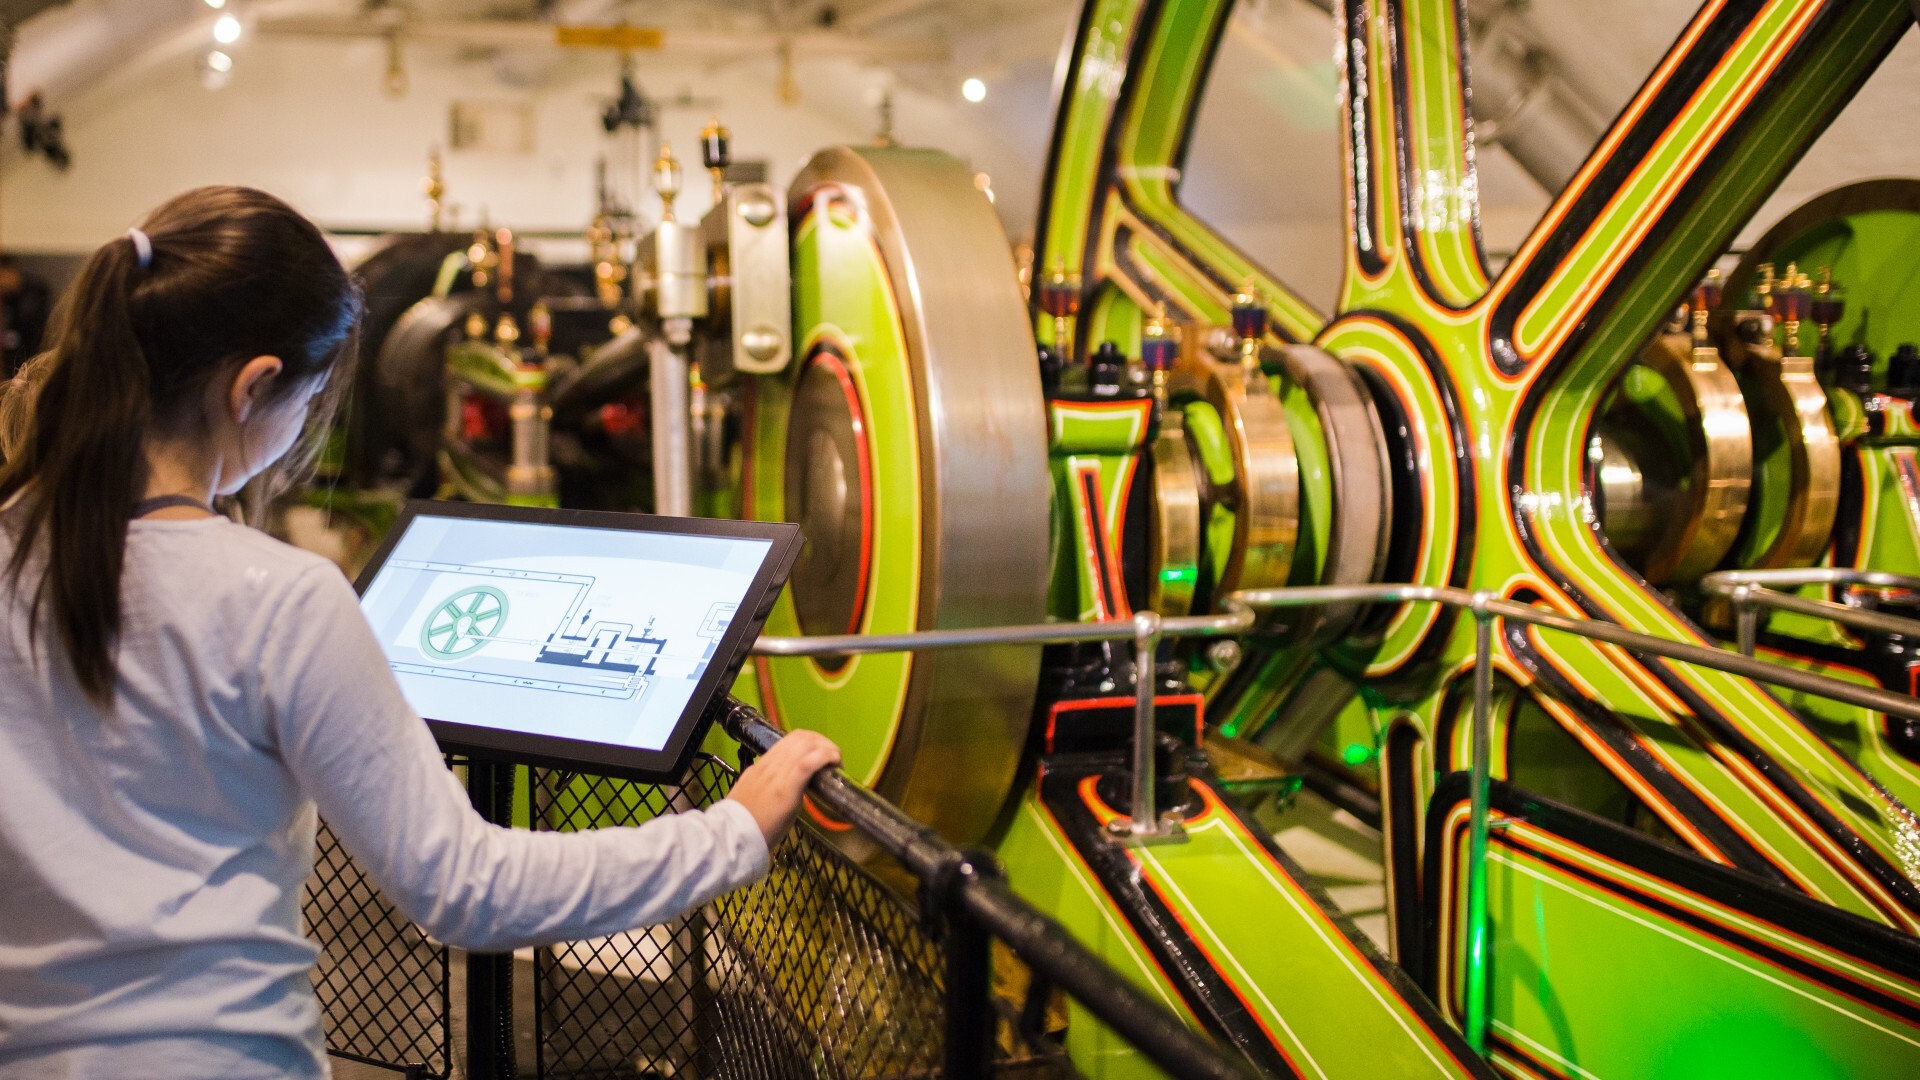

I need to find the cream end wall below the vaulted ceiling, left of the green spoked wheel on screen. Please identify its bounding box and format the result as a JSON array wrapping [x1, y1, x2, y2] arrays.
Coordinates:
[[0, 27, 1066, 252]]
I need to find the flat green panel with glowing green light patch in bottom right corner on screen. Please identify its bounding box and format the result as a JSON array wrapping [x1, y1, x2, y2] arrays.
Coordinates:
[[1448, 813, 1920, 1080]]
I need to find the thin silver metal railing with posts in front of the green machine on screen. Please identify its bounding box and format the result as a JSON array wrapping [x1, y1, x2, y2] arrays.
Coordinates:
[[753, 571, 1920, 1061]]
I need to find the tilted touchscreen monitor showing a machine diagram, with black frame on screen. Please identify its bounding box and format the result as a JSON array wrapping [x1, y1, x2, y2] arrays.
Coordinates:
[[357, 502, 799, 780]]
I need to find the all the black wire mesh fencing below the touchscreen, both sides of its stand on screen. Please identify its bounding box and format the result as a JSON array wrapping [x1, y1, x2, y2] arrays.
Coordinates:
[[303, 755, 1071, 1080]]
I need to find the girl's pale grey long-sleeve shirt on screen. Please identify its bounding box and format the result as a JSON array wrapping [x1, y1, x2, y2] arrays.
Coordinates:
[[0, 519, 766, 1080]]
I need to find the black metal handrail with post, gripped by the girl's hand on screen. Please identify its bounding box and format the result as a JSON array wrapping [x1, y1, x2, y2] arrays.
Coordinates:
[[716, 700, 1248, 1080]]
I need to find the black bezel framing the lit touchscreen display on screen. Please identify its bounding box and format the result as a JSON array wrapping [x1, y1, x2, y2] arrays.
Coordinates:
[[353, 500, 801, 784]]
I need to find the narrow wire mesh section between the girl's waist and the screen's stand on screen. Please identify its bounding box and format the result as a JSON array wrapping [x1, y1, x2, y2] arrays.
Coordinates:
[[301, 810, 453, 1076]]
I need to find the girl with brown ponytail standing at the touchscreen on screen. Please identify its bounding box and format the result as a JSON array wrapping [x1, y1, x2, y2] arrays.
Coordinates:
[[0, 188, 837, 1080]]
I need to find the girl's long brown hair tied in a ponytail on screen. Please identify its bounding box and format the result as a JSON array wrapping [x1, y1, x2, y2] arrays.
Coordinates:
[[0, 186, 361, 705]]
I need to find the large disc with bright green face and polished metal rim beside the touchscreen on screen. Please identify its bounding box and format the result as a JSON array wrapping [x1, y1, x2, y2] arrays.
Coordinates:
[[745, 148, 1050, 846]]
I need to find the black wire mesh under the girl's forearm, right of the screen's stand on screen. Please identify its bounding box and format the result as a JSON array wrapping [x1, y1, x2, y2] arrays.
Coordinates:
[[534, 757, 1058, 1080]]
